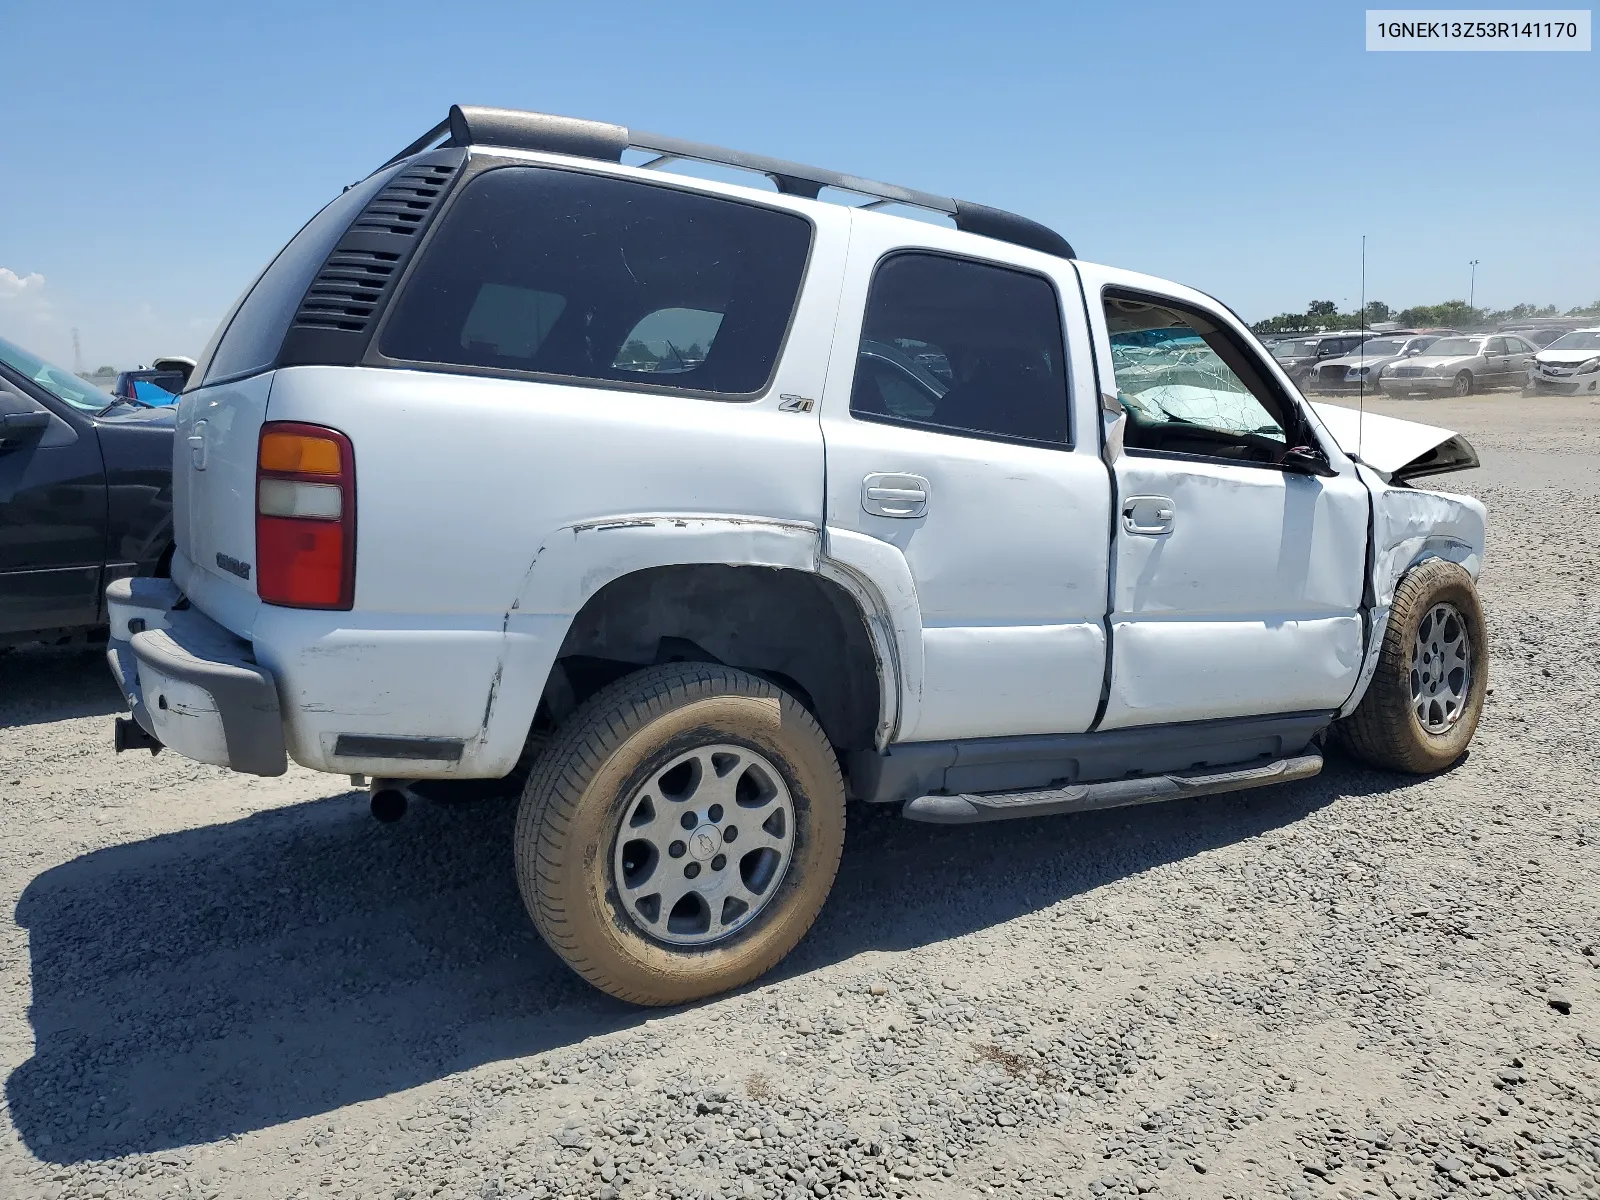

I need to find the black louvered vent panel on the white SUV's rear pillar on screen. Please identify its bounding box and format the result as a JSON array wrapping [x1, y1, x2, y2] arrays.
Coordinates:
[[280, 155, 459, 352]]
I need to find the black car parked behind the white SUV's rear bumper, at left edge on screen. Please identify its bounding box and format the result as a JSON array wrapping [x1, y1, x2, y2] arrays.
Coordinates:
[[0, 339, 174, 646]]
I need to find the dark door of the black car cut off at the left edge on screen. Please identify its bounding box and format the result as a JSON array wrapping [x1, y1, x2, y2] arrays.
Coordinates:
[[0, 376, 106, 638]]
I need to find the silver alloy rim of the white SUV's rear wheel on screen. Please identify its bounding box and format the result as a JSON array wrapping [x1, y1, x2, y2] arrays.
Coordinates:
[[611, 742, 795, 946]]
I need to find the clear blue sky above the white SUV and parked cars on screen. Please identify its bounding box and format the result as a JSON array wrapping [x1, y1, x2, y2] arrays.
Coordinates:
[[0, 0, 1600, 368]]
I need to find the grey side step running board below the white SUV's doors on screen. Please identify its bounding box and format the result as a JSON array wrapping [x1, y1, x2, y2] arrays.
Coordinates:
[[901, 754, 1322, 826]]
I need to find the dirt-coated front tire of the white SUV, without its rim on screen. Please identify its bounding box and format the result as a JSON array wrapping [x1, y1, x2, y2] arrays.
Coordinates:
[[1334, 558, 1490, 774]]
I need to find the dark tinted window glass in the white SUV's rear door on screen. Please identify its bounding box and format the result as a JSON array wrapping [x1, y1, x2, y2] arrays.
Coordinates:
[[850, 253, 1067, 443]]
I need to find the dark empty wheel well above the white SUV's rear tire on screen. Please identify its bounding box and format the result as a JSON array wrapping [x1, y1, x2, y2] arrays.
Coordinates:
[[539, 563, 882, 754]]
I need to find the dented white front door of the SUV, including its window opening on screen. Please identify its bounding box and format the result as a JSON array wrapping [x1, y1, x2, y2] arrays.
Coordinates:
[[1082, 267, 1370, 730]]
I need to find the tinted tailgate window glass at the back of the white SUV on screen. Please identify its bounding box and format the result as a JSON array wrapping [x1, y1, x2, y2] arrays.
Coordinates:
[[195, 165, 400, 384]]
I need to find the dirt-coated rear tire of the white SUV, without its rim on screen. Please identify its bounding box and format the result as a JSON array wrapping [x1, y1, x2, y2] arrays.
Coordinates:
[[515, 662, 845, 1005]]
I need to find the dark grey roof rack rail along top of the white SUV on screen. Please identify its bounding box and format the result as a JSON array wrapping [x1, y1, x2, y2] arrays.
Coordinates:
[[379, 104, 1077, 258]]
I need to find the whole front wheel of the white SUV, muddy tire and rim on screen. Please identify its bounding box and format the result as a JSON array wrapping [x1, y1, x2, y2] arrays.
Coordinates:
[[1334, 558, 1490, 774]]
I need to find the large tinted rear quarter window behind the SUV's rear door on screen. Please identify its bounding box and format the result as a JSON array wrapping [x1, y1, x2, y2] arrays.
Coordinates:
[[379, 166, 811, 395]]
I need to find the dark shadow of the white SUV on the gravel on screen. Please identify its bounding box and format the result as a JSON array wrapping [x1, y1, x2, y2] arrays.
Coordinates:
[[6, 761, 1394, 1163]]
